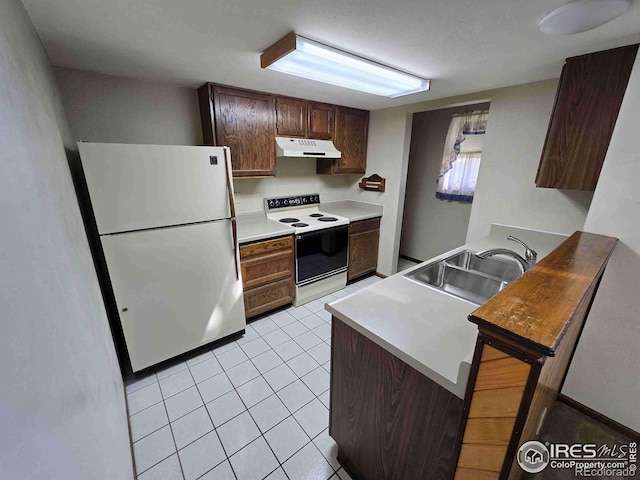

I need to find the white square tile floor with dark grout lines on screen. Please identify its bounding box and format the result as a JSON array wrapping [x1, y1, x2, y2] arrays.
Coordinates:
[[126, 277, 380, 480]]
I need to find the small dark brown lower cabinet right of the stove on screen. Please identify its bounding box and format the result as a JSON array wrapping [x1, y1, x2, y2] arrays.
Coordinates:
[[347, 218, 380, 280]]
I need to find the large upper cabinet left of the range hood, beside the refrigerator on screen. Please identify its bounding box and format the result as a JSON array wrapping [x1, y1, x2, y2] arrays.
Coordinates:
[[198, 84, 276, 177]]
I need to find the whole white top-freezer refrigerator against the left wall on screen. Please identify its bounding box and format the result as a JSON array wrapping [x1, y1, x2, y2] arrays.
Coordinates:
[[78, 142, 246, 372]]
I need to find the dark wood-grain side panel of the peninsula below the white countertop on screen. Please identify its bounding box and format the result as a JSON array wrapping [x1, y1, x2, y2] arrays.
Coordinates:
[[329, 317, 462, 480]]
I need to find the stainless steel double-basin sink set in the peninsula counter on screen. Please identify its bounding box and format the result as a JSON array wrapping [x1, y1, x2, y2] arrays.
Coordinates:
[[404, 250, 521, 305]]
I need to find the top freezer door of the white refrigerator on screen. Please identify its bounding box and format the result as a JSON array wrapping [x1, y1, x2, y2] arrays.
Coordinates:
[[78, 142, 233, 235]]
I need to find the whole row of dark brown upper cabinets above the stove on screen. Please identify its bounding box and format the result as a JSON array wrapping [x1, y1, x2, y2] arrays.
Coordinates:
[[198, 83, 369, 177]]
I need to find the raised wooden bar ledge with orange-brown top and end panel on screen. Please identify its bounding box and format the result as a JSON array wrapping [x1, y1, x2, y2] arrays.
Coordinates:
[[455, 232, 617, 480]]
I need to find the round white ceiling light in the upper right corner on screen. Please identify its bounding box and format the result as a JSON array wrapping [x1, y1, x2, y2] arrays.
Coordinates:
[[540, 0, 631, 35]]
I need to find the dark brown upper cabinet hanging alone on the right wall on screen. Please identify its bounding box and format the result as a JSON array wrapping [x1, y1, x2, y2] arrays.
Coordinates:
[[536, 45, 638, 190]]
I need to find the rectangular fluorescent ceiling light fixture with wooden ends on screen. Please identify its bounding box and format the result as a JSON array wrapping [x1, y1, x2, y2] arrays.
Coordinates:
[[260, 32, 431, 98]]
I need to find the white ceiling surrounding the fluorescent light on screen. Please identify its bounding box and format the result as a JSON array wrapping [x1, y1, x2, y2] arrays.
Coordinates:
[[23, 0, 640, 110]]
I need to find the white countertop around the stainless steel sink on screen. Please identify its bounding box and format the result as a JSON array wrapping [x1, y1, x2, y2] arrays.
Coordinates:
[[325, 225, 566, 398]]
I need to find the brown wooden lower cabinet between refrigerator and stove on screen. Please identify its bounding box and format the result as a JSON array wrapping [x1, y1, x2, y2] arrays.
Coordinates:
[[240, 235, 295, 318]]
